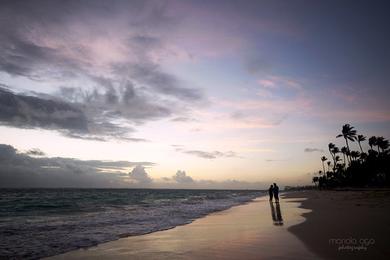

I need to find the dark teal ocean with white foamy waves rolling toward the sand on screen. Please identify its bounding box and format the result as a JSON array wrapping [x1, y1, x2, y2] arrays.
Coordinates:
[[0, 189, 264, 259]]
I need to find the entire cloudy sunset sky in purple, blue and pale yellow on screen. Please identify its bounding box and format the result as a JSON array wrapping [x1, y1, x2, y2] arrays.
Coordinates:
[[0, 0, 390, 189]]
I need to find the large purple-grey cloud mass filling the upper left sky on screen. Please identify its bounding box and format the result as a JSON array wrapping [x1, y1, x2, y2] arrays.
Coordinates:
[[0, 1, 203, 137]]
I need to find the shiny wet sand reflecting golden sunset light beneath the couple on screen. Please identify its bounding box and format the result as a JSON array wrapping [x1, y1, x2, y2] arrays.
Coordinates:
[[47, 197, 319, 259]]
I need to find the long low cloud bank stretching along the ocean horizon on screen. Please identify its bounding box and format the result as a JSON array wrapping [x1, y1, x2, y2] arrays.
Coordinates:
[[0, 144, 266, 189]]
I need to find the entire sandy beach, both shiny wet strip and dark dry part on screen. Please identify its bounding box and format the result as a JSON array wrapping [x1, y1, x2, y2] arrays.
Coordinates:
[[50, 191, 390, 259]]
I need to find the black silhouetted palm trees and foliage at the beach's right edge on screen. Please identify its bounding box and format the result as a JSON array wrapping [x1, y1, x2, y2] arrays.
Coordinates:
[[313, 124, 390, 188]]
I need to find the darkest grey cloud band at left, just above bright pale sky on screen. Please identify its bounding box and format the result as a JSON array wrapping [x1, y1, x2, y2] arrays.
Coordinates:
[[0, 88, 154, 142]]
